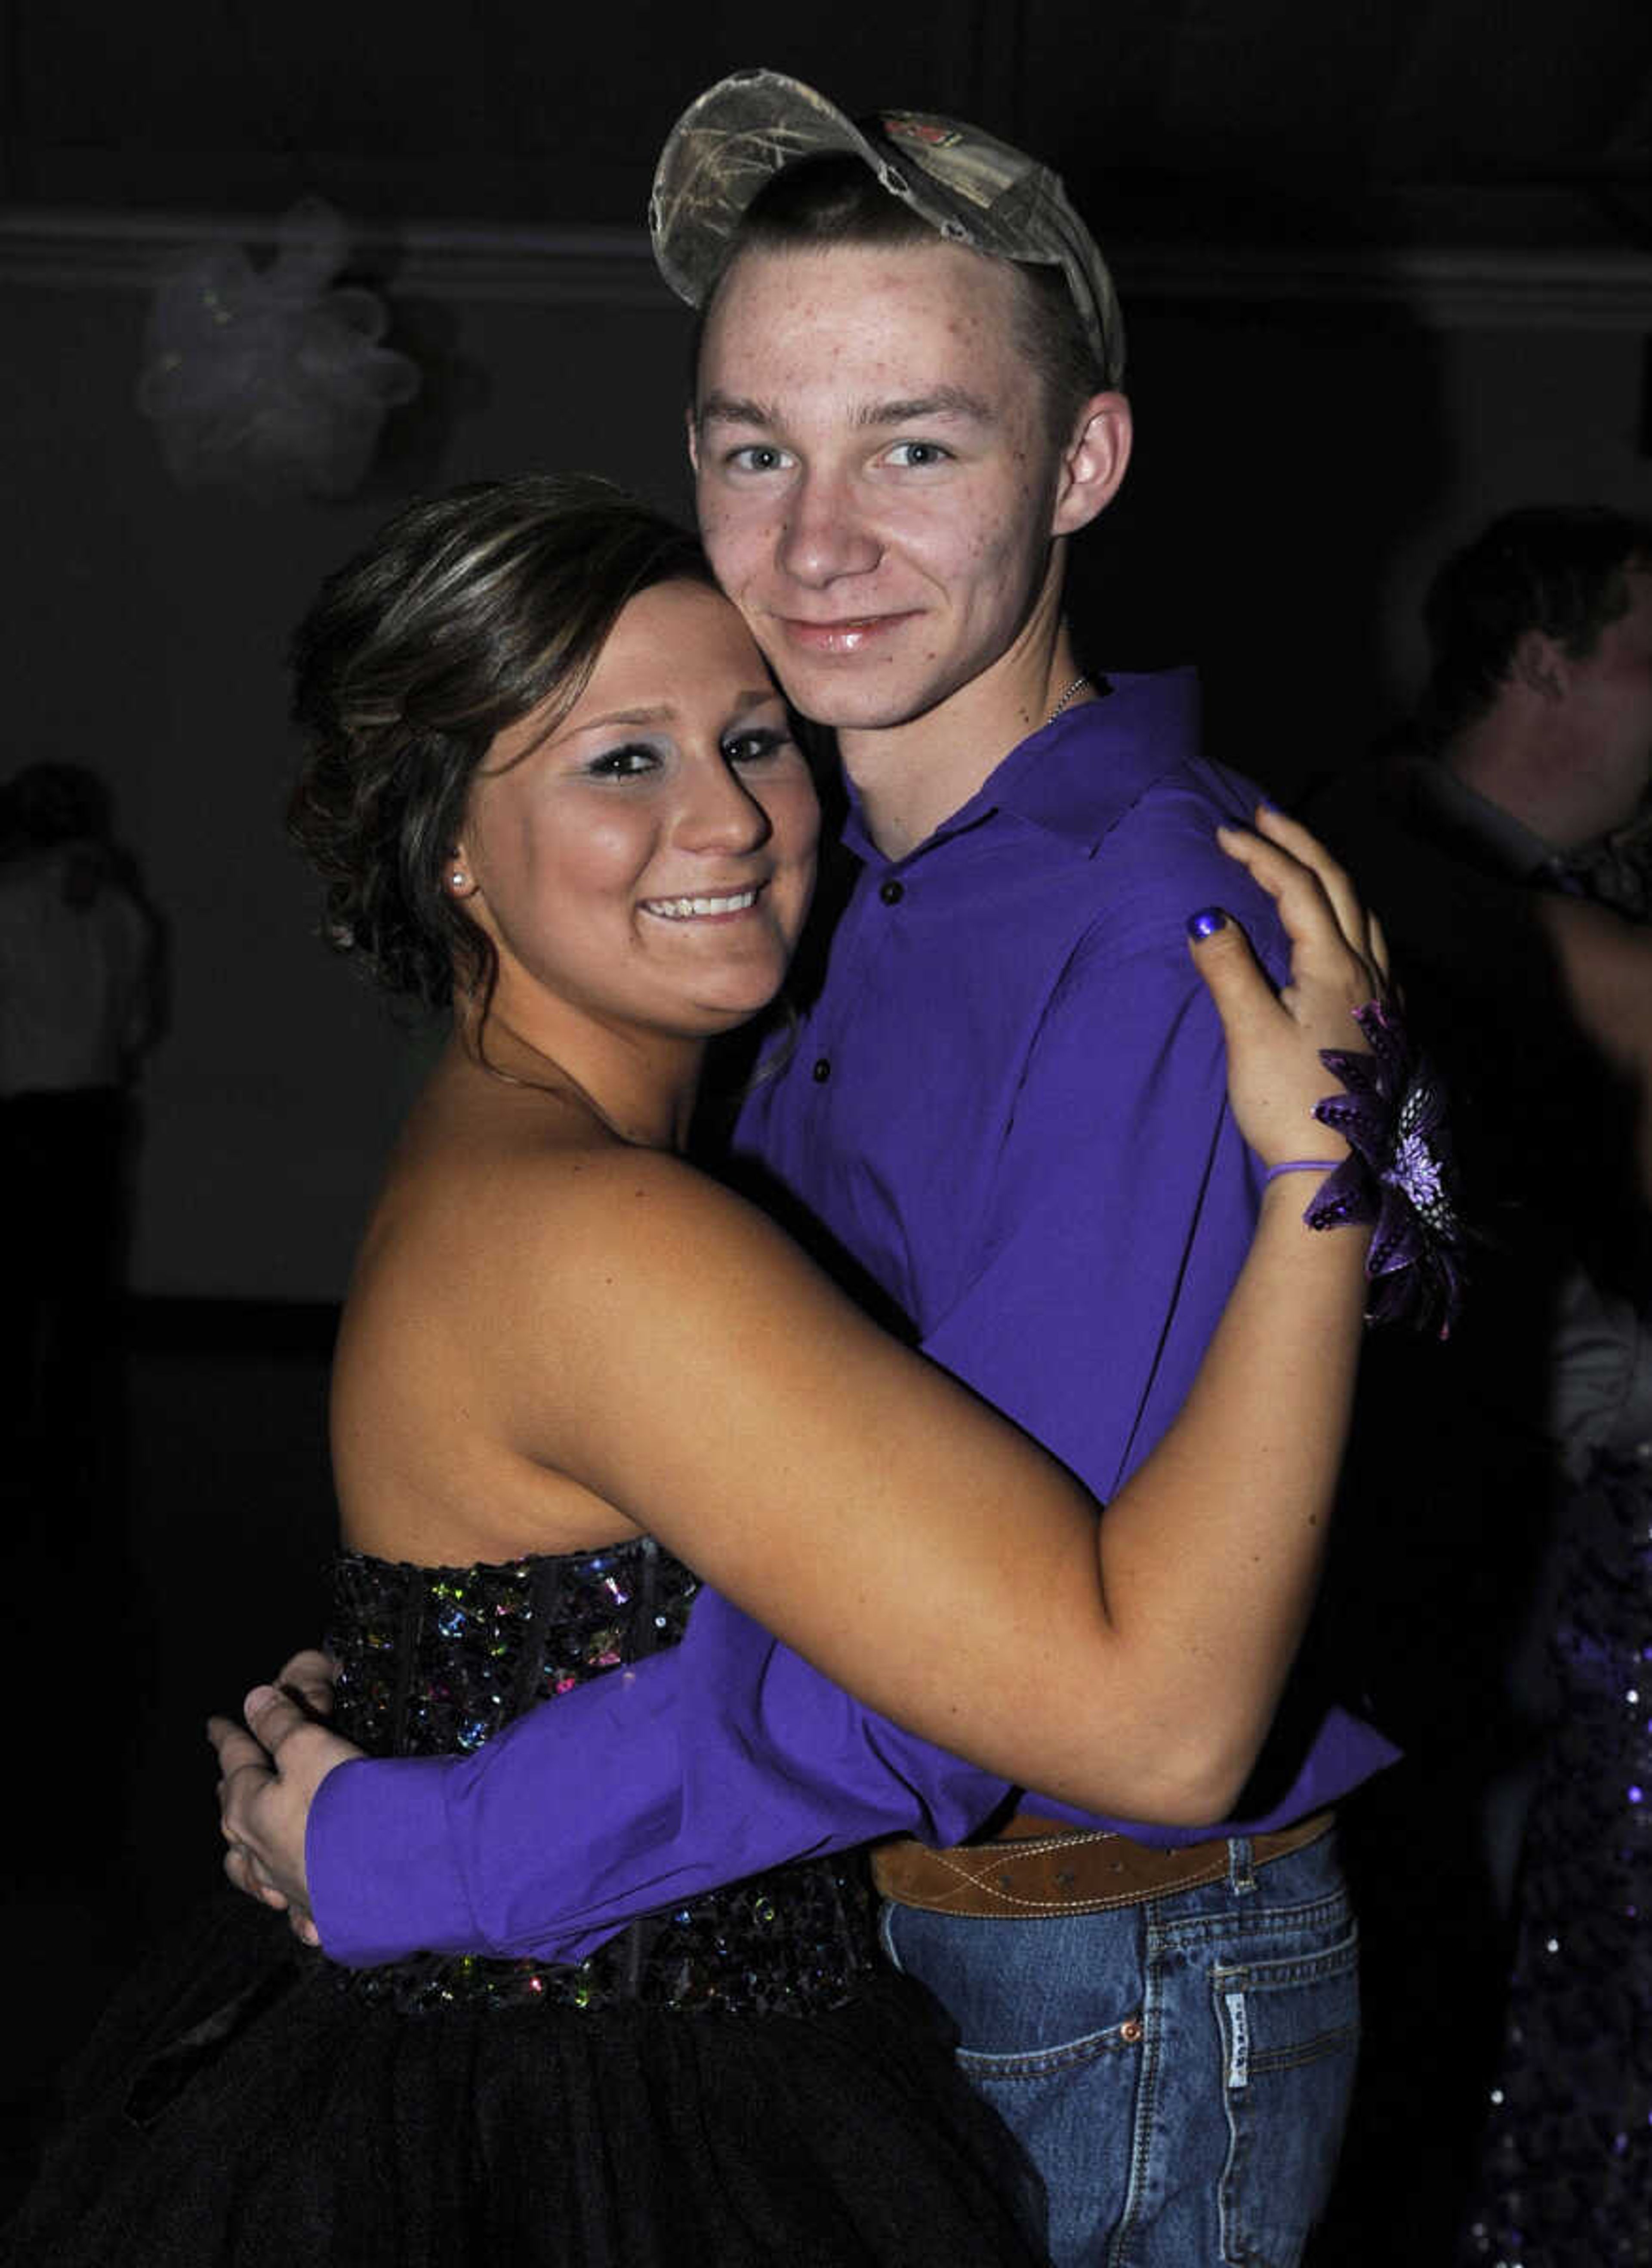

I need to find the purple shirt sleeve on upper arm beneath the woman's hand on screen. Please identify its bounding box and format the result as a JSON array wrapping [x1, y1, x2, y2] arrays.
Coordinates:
[[922, 812, 1279, 1501]]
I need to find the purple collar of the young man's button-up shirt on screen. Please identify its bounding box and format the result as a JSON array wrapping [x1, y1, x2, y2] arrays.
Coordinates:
[[844, 669, 1198, 866]]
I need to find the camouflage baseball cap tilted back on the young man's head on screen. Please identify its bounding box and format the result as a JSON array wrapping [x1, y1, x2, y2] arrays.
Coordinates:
[[649, 70, 1123, 385]]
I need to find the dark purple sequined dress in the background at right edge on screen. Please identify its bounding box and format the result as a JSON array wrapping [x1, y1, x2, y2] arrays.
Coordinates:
[[1461, 1458, 1652, 2268]]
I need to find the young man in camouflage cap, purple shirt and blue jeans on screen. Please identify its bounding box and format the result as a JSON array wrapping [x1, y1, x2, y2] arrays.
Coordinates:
[[225, 73, 1391, 2263]]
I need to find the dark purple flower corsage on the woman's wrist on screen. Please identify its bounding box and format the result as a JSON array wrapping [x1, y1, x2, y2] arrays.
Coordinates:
[[1303, 1000, 1464, 1338]]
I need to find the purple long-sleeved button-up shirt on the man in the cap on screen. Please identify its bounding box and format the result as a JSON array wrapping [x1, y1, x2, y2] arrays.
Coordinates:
[[308, 672, 1393, 1962]]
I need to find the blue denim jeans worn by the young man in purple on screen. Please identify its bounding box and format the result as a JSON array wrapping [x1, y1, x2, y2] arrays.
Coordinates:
[[883, 1835, 1359, 2268]]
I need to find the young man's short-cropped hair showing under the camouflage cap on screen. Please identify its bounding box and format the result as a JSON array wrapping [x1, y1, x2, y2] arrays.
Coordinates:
[[694, 157, 1107, 447]]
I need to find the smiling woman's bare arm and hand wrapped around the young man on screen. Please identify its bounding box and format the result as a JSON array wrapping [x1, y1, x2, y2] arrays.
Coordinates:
[[453, 821, 1375, 1819]]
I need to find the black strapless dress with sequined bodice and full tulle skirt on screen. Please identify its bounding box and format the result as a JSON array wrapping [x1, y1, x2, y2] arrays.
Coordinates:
[[0, 1542, 1042, 2268]]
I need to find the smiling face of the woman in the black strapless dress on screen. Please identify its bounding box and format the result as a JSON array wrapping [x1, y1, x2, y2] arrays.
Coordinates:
[[458, 583, 819, 1039]]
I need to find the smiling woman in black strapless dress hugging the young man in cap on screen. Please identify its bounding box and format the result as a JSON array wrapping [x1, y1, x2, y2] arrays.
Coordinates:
[[14, 478, 1380, 2268]]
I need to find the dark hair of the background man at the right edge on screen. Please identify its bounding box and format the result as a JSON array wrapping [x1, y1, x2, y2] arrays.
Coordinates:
[[1423, 503, 1652, 744]]
